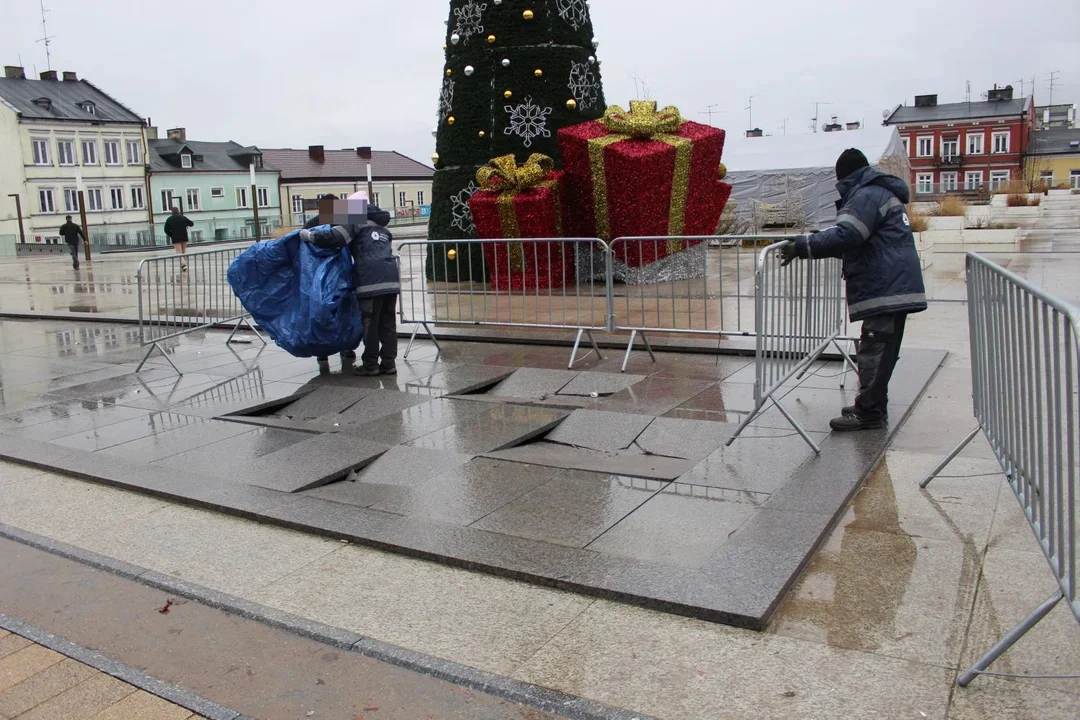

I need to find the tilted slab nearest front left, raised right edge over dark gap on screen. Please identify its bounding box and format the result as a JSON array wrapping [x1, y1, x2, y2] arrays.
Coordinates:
[[248, 435, 390, 492]]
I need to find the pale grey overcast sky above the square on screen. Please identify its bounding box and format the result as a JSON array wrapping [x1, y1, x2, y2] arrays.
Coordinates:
[[0, 0, 1080, 162]]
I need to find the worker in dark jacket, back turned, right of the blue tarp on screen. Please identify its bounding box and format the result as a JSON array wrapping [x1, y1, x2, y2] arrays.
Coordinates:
[[350, 205, 402, 376]]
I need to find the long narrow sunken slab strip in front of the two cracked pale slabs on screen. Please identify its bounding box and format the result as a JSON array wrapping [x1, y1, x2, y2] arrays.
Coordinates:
[[484, 443, 693, 480]]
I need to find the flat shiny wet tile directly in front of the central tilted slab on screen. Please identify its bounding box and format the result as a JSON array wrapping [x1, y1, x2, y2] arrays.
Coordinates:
[[372, 458, 563, 527]]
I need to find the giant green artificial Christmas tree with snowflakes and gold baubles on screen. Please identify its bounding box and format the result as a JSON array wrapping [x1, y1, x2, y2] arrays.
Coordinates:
[[427, 0, 606, 282]]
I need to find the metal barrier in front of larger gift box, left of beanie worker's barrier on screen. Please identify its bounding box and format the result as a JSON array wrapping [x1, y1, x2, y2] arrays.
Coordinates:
[[609, 235, 781, 372]]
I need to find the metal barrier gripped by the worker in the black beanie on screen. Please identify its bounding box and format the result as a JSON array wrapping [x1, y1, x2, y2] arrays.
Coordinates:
[[727, 241, 855, 454]]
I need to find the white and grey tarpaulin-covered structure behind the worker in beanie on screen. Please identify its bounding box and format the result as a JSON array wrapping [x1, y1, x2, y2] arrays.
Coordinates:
[[724, 126, 912, 229]]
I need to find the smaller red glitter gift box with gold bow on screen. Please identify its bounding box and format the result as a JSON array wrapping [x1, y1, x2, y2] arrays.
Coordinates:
[[469, 153, 573, 290]]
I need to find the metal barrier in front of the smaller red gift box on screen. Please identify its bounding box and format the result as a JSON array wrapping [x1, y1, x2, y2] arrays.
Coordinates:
[[399, 239, 611, 368]]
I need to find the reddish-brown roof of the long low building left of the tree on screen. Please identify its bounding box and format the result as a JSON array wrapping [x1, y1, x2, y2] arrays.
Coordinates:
[[262, 148, 435, 180]]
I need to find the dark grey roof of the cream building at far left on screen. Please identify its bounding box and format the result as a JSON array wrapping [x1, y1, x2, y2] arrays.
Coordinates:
[[0, 78, 143, 125]]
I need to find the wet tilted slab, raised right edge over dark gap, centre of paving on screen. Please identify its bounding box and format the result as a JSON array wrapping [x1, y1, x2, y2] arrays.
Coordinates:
[[409, 405, 568, 454]]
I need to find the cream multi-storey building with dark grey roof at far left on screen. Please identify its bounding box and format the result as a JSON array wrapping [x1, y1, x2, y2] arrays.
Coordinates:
[[0, 67, 151, 245]]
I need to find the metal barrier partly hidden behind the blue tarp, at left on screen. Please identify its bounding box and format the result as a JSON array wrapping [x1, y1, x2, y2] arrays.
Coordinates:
[[135, 246, 267, 375]]
